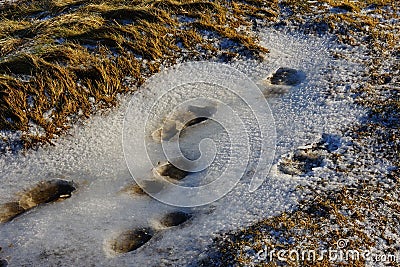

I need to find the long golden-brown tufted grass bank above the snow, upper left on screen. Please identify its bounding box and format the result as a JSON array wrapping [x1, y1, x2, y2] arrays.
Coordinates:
[[0, 0, 277, 150]]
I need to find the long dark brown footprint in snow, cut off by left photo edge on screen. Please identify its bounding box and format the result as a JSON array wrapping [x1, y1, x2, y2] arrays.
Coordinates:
[[0, 179, 76, 222]]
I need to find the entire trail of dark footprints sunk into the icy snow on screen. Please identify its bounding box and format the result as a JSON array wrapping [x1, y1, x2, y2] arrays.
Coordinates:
[[0, 68, 308, 262]]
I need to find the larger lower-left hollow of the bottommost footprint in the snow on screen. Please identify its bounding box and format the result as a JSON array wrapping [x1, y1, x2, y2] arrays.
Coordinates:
[[111, 228, 153, 253]]
